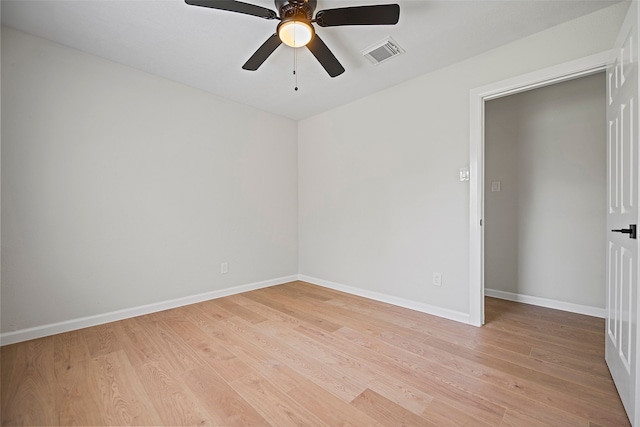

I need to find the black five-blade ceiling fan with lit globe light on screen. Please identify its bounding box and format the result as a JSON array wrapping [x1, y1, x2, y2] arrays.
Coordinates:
[[185, 0, 400, 77]]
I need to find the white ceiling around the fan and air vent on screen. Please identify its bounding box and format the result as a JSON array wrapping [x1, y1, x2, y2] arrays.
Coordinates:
[[1, 0, 618, 120]]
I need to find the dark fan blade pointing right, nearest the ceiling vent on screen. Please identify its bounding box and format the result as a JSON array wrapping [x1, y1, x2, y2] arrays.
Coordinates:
[[316, 4, 400, 27]]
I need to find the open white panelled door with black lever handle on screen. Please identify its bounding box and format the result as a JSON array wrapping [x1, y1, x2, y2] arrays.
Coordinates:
[[605, 1, 640, 421]]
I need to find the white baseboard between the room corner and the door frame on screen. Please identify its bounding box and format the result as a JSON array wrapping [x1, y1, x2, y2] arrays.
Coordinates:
[[298, 274, 470, 324]]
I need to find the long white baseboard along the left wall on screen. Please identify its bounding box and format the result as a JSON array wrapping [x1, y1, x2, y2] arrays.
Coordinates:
[[0, 275, 298, 345]]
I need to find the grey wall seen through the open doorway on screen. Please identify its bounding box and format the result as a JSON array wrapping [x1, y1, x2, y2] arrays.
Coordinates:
[[484, 73, 606, 309]]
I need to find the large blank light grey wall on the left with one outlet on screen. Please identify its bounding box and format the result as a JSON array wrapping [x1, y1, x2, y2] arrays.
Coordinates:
[[1, 27, 297, 332]]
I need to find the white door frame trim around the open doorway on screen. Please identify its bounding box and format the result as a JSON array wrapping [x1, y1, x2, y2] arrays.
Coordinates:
[[469, 50, 616, 330]]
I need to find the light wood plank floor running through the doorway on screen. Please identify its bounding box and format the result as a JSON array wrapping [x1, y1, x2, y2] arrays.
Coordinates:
[[1, 282, 629, 427]]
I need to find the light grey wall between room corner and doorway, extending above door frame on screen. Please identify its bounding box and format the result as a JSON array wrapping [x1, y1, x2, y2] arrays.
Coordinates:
[[298, 4, 628, 314]]
